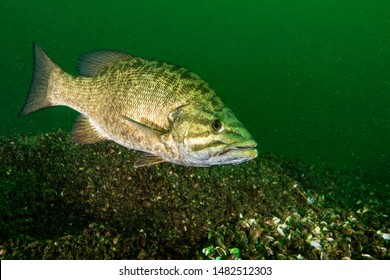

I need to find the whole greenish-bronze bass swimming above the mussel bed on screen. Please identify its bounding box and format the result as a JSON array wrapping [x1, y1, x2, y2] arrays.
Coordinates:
[[21, 43, 258, 167]]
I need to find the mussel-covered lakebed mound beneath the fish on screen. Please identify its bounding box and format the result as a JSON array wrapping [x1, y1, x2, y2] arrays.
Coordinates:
[[0, 131, 390, 260]]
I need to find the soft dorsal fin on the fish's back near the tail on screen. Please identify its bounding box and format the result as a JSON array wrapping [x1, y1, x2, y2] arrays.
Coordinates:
[[77, 50, 133, 77]]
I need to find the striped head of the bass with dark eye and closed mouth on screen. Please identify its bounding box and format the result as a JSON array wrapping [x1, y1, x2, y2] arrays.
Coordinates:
[[169, 99, 257, 166]]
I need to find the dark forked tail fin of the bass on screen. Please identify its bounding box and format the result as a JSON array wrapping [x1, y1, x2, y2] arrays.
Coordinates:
[[21, 43, 60, 115]]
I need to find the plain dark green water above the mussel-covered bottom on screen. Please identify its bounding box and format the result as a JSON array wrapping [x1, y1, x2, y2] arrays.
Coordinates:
[[0, 0, 390, 180]]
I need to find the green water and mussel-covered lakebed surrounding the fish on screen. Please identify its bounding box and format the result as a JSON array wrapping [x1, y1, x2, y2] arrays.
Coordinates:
[[0, 0, 390, 259]]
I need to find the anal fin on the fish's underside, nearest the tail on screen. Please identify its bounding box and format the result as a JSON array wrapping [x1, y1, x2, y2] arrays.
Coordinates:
[[72, 115, 107, 144]]
